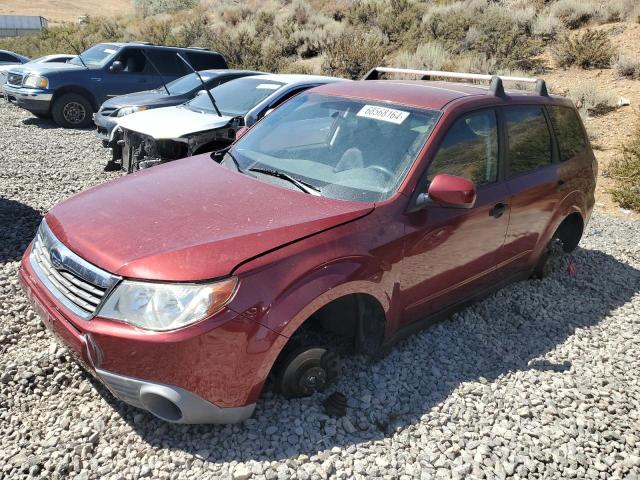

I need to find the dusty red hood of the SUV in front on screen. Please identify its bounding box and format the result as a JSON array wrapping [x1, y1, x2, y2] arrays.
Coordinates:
[[46, 154, 374, 281]]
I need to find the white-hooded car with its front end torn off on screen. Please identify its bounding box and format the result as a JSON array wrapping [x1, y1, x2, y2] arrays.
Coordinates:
[[119, 74, 347, 172]]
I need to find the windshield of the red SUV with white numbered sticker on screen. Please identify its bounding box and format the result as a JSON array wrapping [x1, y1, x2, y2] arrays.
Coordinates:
[[224, 93, 440, 202]]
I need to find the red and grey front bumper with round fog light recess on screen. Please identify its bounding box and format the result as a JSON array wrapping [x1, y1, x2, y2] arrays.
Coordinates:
[[19, 249, 286, 423]]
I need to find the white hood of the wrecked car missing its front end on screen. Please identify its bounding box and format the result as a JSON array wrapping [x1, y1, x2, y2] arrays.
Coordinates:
[[119, 106, 232, 140]]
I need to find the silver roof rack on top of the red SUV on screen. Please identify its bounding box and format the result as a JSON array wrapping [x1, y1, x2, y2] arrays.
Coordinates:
[[362, 67, 549, 97]]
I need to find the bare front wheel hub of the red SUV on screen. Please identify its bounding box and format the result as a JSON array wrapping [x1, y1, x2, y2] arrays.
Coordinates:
[[276, 347, 338, 398]]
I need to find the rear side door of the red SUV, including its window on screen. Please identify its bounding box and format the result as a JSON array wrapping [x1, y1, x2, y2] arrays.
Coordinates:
[[502, 105, 562, 275]]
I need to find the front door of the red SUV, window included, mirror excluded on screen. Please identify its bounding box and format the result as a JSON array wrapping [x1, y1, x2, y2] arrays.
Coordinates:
[[401, 109, 509, 323]]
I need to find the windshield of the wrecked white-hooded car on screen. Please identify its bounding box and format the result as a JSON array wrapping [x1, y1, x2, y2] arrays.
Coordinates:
[[187, 75, 284, 117]]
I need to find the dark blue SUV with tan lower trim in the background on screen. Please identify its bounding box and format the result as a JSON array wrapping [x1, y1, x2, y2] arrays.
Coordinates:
[[3, 42, 227, 128]]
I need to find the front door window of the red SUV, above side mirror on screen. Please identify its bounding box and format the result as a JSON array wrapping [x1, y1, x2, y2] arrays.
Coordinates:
[[427, 110, 498, 185]]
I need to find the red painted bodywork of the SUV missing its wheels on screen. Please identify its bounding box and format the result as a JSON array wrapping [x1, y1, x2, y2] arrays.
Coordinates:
[[20, 81, 595, 406]]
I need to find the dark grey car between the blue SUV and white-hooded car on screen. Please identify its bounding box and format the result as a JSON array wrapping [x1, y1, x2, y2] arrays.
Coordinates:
[[93, 69, 261, 168]]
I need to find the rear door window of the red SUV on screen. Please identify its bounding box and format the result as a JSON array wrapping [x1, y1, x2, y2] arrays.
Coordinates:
[[504, 106, 551, 176]]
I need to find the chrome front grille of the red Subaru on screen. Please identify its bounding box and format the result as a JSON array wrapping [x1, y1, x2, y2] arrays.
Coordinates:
[[31, 221, 120, 319]]
